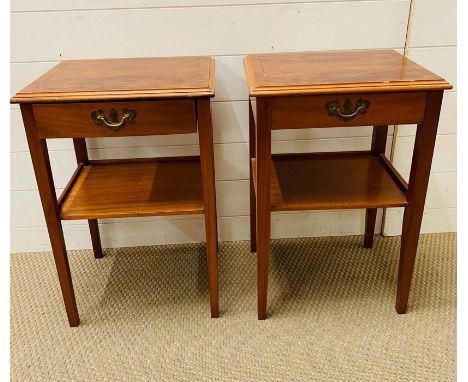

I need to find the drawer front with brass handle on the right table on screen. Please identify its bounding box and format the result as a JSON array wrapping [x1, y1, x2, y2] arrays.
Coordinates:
[[271, 92, 427, 129]]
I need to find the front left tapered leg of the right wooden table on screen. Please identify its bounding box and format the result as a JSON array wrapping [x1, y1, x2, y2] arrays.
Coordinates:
[[256, 98, 271, 320]]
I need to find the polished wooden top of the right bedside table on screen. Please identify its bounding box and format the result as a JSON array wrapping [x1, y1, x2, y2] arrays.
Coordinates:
[[244, 50, 452, 97]]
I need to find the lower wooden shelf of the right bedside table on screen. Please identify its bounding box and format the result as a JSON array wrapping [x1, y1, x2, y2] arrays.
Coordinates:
[[252, 151, 407, 211]]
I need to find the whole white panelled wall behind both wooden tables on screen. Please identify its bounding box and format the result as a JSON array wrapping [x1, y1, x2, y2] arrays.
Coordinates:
[[11, 0, 456, 252]]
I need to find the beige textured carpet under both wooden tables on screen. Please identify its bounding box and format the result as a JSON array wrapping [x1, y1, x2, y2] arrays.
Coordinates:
[[11, 234, 456, 382]]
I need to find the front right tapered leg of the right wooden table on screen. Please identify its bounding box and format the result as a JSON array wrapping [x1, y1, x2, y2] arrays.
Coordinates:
[[396, 91, 443, 314]]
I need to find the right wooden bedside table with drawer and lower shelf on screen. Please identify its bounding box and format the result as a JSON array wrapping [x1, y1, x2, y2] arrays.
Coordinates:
[[244, 50, 452, 319]]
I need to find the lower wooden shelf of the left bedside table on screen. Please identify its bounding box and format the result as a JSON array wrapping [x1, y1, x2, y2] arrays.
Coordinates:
[[59, 157, 203, 220]]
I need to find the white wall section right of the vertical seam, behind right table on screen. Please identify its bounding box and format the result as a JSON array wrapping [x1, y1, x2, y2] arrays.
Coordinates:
[[383, 0, 457, 235]]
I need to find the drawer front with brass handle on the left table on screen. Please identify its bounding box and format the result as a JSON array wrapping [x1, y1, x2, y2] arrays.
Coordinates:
[[33, 99, 197, 138]]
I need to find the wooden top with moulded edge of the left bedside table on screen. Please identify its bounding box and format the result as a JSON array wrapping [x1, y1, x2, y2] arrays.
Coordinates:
[[11, 57, 214, 103]]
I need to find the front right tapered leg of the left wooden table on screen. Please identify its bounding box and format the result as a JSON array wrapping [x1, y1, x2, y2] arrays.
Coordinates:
[[197, 99, 219, 318]]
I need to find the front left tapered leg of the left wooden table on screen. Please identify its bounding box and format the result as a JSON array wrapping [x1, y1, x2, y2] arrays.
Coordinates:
[[21, 105, 80, 326]]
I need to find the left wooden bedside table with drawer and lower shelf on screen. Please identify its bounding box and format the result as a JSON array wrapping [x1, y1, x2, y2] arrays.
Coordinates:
[[11, 57, 218, 326]]
